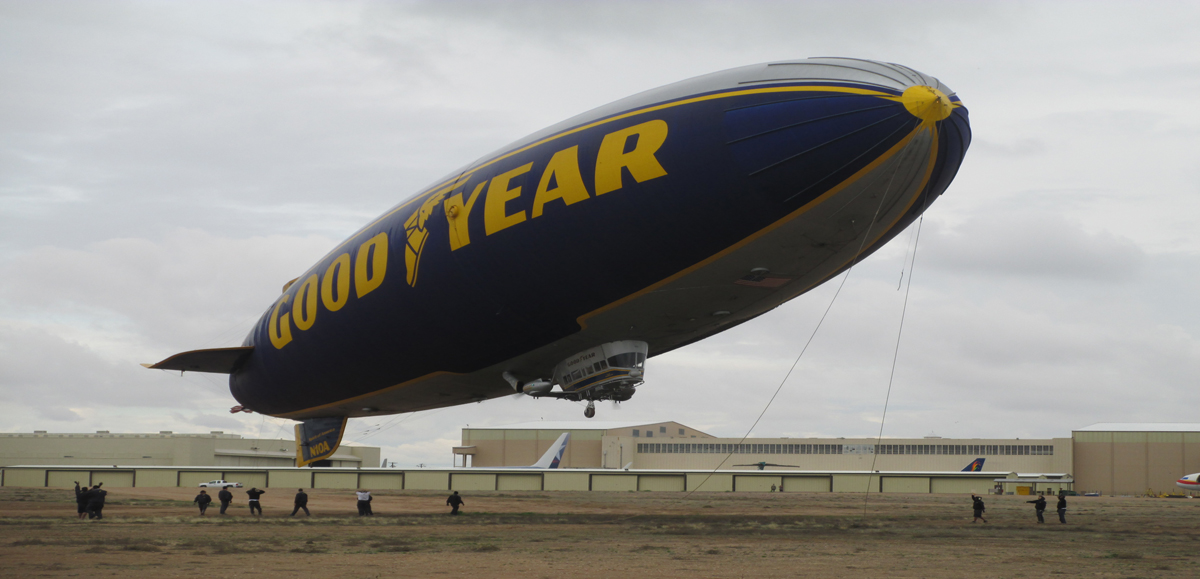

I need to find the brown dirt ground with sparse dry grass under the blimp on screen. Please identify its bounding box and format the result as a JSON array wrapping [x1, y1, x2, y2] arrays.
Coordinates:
[[0, 488, 1200, 579]]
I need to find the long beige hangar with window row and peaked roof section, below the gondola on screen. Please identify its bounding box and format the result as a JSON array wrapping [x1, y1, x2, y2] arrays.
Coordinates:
[[455, 420, 1072, 474]]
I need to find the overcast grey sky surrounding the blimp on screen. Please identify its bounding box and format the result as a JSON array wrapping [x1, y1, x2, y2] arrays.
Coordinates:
[[0, 0, 1200, 466]]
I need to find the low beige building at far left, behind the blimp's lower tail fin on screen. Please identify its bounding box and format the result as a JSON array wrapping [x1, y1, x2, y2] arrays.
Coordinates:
[[0, 430, 379, 467]]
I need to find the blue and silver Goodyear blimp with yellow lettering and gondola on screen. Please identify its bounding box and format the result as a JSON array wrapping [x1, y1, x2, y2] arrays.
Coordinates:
[[148, 58, 971, 465]]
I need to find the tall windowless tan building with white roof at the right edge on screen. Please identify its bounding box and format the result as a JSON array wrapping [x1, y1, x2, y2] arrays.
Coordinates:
[[1072, 423, 1200, 495]]
